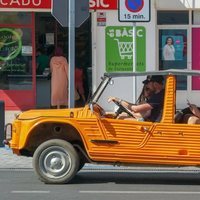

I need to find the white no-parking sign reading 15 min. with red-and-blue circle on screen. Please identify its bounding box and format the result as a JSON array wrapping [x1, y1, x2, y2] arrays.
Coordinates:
[[118, 0, 151, 22]]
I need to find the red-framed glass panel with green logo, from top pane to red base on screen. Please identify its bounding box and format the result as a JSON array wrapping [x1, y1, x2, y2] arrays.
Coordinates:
[[0, 12, 35, 110]]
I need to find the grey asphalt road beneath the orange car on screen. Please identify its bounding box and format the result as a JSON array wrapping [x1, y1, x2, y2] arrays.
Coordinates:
[[0, 169, 200, 200]]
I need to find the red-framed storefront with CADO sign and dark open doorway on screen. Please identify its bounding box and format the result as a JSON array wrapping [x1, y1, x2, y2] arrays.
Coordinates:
[[0, 0, 91, 111]]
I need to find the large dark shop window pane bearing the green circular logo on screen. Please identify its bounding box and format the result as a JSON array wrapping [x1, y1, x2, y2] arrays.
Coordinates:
[[0, 27, 33, 90]]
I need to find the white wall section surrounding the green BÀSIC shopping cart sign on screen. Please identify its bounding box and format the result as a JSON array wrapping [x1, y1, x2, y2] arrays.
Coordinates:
[[92, 0, 157, 110]]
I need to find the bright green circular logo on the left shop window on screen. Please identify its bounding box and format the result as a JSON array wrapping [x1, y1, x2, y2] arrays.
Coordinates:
[[0, 28, 22, 61]]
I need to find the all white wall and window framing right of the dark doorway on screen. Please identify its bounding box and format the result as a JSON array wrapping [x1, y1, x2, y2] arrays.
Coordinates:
[[93, 0, 200, 110]]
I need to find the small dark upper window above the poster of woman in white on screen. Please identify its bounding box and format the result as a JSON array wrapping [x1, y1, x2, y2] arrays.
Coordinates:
[[157, 11, 189, 25]]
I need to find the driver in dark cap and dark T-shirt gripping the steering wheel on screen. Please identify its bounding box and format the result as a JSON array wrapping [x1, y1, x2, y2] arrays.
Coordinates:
[[108, 75, 164, 122]]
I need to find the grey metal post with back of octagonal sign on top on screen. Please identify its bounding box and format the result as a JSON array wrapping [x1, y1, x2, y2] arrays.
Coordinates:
[[52, 0, 89, 108]]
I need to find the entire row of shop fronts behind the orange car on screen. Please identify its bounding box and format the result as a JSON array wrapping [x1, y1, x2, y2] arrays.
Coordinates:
[[0, 0, 200, 110]]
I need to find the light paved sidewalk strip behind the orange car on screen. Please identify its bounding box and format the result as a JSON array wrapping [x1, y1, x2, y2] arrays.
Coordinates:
[[0, 146, 200, 175]]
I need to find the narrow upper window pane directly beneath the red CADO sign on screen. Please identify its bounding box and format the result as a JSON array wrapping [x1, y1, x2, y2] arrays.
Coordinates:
[[0, 12, 31, 24]]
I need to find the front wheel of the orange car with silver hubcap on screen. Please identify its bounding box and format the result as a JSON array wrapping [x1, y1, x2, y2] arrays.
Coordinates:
[[33, 139, 80, 184]]
